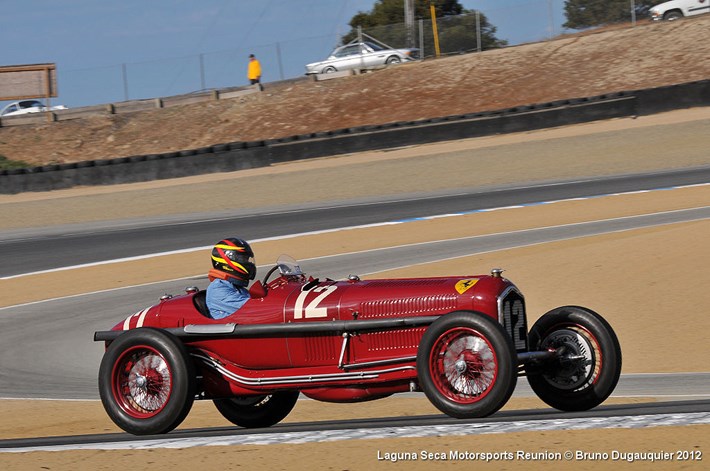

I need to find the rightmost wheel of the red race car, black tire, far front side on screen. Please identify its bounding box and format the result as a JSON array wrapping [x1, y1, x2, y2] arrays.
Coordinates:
[[527, 306, 621, 411]]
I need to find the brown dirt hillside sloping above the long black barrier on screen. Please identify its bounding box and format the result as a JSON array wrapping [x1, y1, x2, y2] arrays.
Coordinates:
[[0, 15, 710, 165]]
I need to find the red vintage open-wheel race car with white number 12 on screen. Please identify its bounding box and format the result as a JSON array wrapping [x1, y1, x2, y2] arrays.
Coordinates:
[[94, 256, 621, 434]]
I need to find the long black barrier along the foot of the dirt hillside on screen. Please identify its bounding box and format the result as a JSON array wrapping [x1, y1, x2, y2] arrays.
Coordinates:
[[0, 80, 710, 194]]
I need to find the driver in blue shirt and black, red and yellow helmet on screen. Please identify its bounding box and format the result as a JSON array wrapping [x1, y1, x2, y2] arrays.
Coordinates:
[[207, 237, 256, 319]]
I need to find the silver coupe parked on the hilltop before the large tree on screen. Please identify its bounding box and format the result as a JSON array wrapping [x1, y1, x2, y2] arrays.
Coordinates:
[[306, 42, 419, 75]]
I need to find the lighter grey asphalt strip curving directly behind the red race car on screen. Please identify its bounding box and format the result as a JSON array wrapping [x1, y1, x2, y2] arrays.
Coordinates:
[[0, 207, 710, 399]]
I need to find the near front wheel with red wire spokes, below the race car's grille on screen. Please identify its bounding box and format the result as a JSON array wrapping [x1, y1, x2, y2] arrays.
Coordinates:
[[417, 311, 518, 419]]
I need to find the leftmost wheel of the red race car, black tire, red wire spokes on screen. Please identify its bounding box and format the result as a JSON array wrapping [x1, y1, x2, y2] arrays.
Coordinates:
[[99, 328, 195, 435]]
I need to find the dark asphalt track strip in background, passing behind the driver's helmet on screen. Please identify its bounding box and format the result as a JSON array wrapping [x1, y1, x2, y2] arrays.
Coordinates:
[[0, 166, 710, 278]]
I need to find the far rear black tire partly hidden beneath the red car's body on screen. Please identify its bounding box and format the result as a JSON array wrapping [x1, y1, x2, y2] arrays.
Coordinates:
[[213, 391, 298, 428]]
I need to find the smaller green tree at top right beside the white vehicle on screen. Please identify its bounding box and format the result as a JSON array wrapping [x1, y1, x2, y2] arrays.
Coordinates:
[[562, 0, 666, 29]]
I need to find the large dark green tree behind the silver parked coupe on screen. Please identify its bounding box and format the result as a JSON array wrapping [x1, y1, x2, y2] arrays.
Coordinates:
[[341, 0, 507, 53]]
